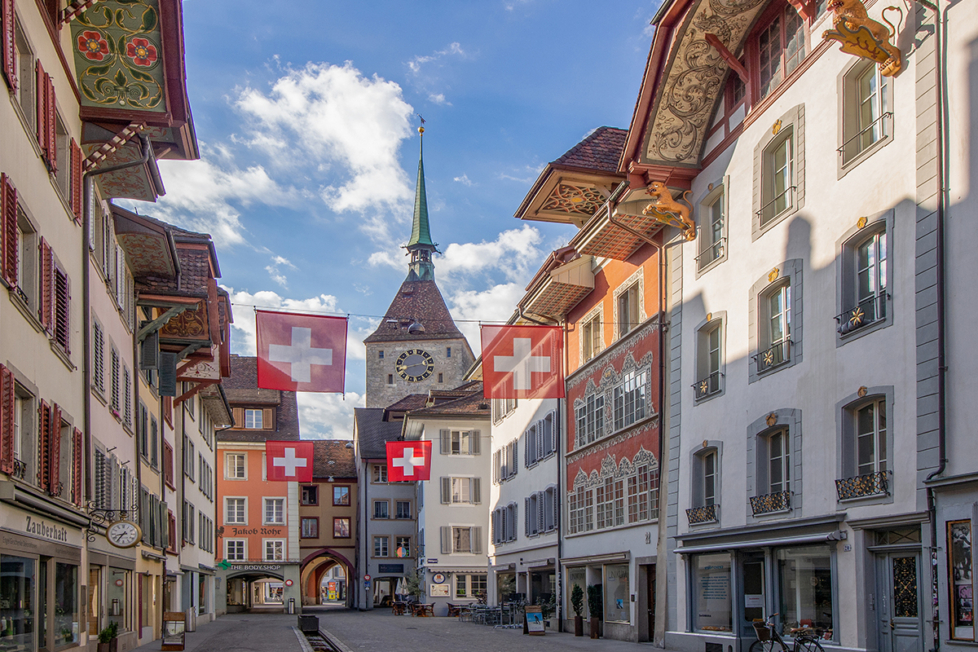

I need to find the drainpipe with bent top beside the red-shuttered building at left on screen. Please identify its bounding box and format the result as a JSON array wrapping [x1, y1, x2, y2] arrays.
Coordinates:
[[82, 134, 153, 498]]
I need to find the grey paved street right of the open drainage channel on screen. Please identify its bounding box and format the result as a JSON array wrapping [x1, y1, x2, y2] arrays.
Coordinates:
[[310, 609, 651, 652]]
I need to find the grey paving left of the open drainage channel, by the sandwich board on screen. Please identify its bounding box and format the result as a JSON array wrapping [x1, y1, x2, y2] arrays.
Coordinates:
[[136, 613, 303, 652]]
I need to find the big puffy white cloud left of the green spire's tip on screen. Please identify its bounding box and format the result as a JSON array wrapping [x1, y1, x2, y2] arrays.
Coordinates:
[[235, 62, 414, 238]]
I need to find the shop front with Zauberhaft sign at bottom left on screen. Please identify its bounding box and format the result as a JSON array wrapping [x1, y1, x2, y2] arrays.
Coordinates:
[[0, 505, 87, 652]]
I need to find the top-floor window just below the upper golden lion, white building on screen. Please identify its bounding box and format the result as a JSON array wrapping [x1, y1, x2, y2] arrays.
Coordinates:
[[839, 60, 893, 168]]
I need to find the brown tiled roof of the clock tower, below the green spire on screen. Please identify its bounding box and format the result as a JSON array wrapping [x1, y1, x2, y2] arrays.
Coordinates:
[[364, 280, 463, 342]]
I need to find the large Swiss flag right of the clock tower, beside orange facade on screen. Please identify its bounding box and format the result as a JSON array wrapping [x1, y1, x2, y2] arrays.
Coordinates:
[[482, 326, 564, 398]]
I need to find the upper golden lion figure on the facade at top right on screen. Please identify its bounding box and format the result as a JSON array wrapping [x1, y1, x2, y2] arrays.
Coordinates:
[[822, 0, 903, 77]]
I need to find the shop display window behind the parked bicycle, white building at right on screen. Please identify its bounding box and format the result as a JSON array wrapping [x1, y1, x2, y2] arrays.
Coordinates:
[[777, 546, 834, 638]]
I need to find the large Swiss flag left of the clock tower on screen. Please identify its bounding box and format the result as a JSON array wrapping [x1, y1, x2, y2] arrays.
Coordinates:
[[257, 310, 347, 392]]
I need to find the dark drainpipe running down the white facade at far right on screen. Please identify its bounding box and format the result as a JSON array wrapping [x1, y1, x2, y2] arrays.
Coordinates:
[[920, 0, 950, 652]]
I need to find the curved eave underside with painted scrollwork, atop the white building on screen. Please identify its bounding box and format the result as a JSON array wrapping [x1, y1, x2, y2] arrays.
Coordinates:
[[641, 0, 766, 166]]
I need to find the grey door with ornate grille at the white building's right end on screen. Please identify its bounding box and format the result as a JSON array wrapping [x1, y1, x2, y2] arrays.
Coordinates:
[[876, 552, 924, 652]]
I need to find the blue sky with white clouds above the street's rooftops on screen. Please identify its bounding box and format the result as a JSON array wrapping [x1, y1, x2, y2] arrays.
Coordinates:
[[138, 0, 658, 438]]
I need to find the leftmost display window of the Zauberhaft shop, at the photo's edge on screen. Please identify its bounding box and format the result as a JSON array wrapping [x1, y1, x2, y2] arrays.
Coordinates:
[[0, 555, 35, 650]]
